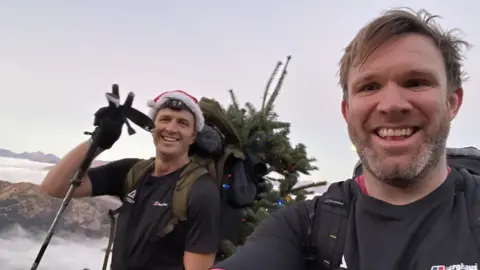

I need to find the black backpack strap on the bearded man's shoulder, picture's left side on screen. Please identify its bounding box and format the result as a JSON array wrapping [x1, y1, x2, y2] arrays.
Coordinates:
[[309, 180, 353, 270]]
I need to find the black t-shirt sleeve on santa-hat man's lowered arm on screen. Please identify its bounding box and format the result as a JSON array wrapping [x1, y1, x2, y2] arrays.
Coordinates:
[[185, 175, 221, 254]]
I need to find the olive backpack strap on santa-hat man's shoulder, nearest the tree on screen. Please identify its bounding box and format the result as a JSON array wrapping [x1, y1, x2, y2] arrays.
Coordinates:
[[158, 162, 209, 237]]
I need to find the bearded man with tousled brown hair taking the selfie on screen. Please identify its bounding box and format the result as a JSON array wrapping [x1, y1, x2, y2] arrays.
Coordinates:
[[209, 9, 480, 270]]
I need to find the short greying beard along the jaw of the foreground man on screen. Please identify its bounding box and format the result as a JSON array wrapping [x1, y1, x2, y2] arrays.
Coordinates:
[[350, 119, 450, 189]]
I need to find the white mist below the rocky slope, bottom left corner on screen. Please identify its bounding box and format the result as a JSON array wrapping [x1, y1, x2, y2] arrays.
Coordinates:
[[0, 226, 108, 270]]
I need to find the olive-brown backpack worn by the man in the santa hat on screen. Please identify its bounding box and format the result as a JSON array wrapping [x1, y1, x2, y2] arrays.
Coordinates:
[[103, 98, 267, 269]]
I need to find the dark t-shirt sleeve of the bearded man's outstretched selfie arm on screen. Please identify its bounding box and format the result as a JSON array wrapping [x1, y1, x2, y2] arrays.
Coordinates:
[[211, 201, 312, 270]]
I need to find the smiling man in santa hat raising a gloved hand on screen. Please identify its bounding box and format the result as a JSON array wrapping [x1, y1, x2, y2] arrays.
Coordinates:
[[41, 90, 220, 270]]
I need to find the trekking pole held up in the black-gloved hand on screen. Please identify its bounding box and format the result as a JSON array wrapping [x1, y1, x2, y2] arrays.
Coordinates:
[[30, 84, 153, 270]]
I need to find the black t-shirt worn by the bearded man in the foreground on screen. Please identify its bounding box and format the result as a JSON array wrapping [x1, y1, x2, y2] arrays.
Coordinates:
[[213, 170, 480, 270]]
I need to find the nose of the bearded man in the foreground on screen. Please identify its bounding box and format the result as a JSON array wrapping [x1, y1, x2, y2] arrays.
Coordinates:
[[377, 83, 412, 115]]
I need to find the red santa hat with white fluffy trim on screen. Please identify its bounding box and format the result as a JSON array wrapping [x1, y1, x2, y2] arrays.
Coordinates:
[[147, 90, 205, 132]]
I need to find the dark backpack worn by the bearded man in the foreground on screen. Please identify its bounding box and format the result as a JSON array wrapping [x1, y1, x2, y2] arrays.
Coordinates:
[[302, 147, 480, 270]]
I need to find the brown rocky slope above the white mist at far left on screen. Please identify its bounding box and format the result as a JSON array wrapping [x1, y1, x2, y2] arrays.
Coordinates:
[[0, 180, 119, 237]]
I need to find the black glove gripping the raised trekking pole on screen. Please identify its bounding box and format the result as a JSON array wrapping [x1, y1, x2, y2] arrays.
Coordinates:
[[92, 104, 125, 150]]
